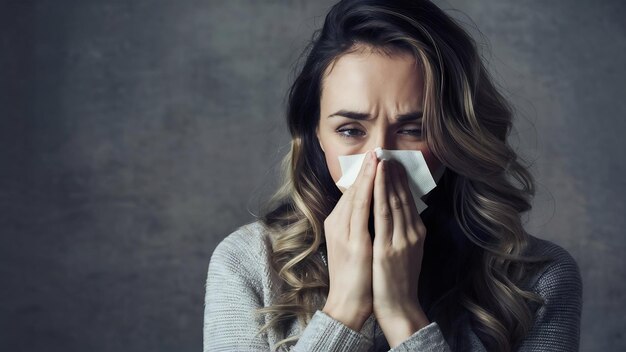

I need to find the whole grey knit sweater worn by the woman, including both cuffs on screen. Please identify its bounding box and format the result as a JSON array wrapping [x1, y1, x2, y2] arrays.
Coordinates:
[[203, 221, 582, 352]]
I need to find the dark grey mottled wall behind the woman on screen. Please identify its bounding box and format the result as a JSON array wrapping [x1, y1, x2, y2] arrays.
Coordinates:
[[0, 0, 626, 351]]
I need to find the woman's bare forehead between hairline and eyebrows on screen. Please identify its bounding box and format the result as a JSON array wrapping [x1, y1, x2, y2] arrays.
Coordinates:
[[322, 50, 423, 108]]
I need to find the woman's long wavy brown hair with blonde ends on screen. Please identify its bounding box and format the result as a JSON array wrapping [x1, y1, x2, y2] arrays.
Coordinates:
[[251, 0, 546, 351]]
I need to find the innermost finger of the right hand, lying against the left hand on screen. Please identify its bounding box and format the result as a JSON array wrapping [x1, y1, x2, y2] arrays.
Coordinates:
[[374, 160, 393, 246]]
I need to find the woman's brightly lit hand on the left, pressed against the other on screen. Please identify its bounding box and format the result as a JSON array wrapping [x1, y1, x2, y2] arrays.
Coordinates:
[[322, 152, 378, 331]]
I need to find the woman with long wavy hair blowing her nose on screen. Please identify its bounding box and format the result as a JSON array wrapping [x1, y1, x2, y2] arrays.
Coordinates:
[[204, 0, 582, 351]]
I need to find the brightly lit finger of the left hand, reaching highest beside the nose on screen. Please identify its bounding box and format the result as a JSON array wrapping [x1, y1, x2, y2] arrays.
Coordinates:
[[350, 152, 377, 241]]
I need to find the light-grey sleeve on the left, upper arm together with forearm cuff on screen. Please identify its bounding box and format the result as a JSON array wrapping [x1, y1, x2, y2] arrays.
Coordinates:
[[203, 227, 373, 352]]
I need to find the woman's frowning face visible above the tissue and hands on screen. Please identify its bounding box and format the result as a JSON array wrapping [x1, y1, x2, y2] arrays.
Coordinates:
[[317, 50, 441, 188]]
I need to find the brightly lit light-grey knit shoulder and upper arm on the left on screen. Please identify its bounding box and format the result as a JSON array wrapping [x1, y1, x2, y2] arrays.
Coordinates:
[[203, 222, 272, 351]]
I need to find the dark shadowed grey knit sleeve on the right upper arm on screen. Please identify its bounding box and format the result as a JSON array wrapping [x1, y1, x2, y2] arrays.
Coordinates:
[[519, 249, 583, 352]]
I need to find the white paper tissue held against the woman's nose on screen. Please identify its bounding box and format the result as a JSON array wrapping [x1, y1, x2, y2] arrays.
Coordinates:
[[336, 148, 444, 213]]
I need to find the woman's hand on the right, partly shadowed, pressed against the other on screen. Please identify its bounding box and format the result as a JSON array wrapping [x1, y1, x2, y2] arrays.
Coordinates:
[[372, 160, 430, 348]]
